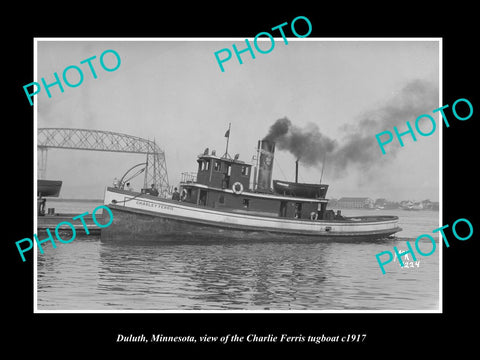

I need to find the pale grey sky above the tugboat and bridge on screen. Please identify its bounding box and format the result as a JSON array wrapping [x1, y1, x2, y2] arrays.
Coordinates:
[[35, 38, 442, 201]]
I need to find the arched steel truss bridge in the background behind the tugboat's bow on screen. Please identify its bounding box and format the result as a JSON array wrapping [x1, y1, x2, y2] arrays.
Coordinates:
[[37, 128, 170, 194]]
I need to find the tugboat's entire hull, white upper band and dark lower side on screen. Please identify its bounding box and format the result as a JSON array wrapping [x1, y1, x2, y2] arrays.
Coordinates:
[[101, 188, 401, 241]]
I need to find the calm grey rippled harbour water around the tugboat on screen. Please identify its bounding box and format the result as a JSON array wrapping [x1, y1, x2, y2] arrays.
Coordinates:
[[37, 202, 439, 310]]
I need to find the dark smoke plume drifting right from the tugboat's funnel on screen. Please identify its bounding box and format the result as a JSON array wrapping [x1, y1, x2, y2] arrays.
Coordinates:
[[264, 80, 439, 177]]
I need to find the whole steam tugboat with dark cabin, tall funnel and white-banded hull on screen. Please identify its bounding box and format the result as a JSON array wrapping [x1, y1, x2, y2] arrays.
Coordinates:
[[101, 140, 401, 241]]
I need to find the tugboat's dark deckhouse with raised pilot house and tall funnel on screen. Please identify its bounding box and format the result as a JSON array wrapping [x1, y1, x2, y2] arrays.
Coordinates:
[[180, 140, 328, 220]]
